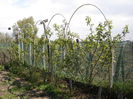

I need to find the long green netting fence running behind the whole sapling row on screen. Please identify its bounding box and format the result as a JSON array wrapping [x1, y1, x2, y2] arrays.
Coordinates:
[[1, 41, 133, 83]]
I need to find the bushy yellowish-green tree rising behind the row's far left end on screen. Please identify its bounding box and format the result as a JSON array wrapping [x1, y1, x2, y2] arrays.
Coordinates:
[[12, 17, 38, 64]]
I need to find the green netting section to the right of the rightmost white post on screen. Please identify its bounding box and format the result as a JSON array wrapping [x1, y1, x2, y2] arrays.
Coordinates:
[[114, 41, 133, 81]]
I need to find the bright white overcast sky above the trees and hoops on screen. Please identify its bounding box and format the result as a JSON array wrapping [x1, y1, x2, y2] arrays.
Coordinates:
[[0, 0, 133, 40]]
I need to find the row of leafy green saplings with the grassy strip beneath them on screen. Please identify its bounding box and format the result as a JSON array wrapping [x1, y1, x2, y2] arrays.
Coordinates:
[[5, 18, 133, 99]]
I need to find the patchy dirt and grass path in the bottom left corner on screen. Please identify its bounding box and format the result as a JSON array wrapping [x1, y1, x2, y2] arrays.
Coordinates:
[[0, 71, 50, 99]]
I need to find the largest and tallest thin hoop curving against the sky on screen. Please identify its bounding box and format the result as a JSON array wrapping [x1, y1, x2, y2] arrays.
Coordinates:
[[66, 3, 108, 32]]
